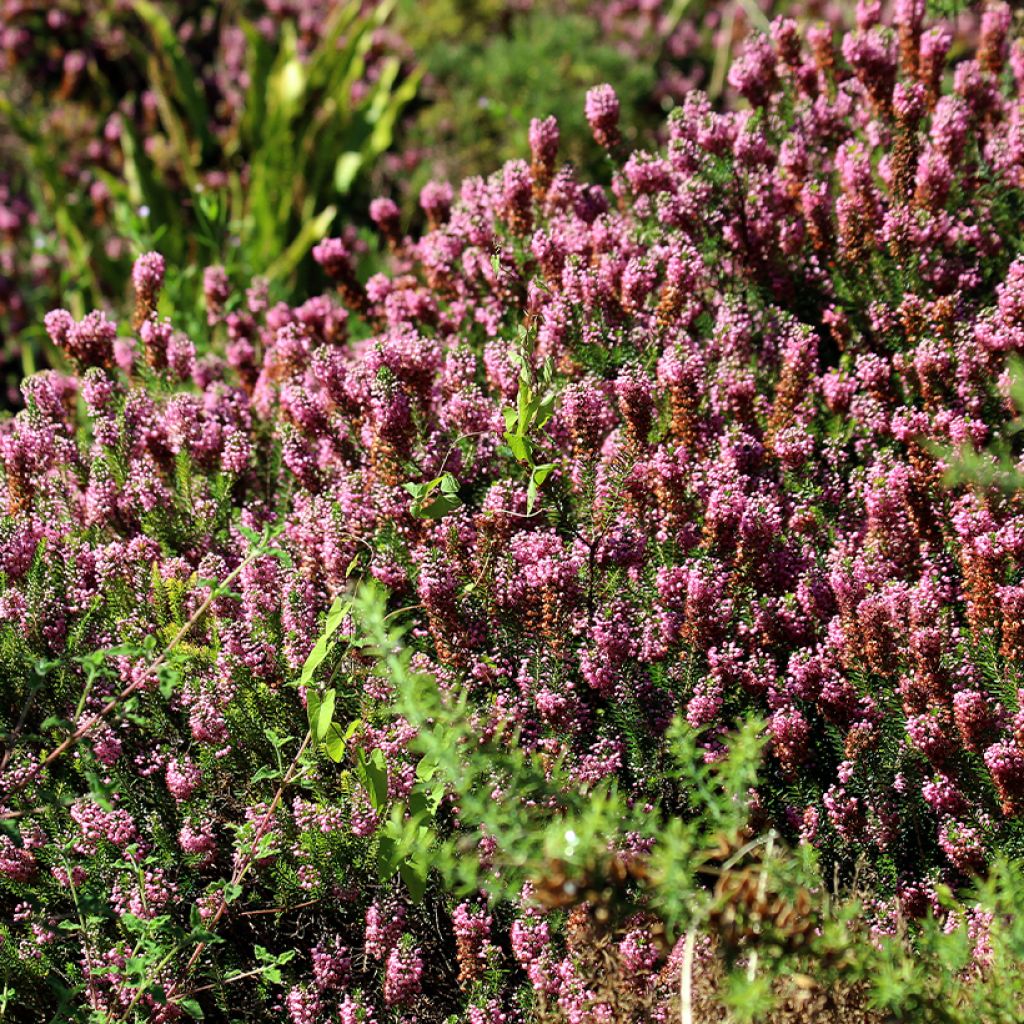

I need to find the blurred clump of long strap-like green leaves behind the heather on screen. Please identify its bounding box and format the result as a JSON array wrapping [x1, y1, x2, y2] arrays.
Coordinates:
[[0, 0, 421, 359]]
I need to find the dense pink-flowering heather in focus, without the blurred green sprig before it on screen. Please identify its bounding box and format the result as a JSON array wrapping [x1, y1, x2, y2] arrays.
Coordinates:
[[0, 2, 1024, 1022]]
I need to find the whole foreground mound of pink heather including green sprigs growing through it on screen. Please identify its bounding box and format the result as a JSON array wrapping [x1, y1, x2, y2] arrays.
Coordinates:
[[0, 3, 1024, 1024]]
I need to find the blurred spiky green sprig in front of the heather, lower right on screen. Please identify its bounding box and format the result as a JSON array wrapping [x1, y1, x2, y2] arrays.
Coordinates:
[[353, 586, 1024, 1024]]
